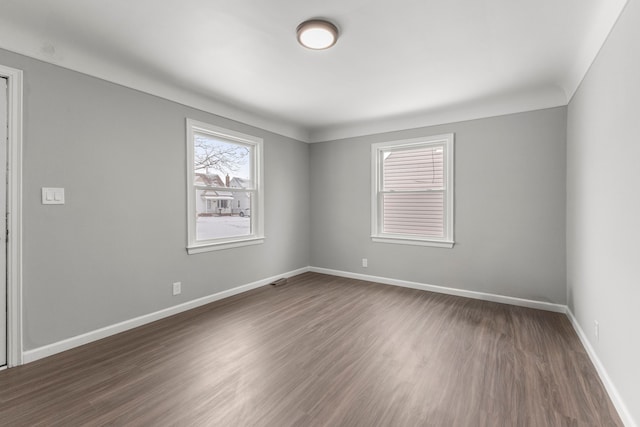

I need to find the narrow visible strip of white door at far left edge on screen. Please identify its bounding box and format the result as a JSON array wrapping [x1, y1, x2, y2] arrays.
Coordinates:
[[0, 77, 8, 366]]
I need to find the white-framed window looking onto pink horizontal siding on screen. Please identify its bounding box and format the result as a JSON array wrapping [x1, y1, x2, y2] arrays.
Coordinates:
[[371, 134, 454, 248]]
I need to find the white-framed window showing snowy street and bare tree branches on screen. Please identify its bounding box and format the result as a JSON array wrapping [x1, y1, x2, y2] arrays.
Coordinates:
[[187, 119, 264, 254]]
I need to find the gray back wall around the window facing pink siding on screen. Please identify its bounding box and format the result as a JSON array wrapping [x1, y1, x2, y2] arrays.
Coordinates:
[[311, 107, 566, 304]]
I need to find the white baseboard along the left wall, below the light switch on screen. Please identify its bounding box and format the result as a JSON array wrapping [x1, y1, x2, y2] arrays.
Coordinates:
[[22, 267, 309, 363]]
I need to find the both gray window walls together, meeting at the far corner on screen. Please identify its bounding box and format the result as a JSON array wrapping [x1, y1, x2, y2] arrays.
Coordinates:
[[0, 47, 566, 350]]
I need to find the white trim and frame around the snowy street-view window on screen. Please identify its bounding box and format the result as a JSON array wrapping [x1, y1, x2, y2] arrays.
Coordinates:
[[186, 119, 264, 255]]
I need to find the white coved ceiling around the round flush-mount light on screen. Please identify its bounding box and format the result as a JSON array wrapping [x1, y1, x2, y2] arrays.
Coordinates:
[[0, 0, 627, 142]]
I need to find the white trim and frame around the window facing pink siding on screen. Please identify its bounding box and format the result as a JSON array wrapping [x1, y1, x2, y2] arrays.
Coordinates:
[[371, 133, 455, 248]]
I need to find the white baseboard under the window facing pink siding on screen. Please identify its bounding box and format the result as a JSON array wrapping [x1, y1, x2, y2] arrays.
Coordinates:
[[309, 267, 567, 313]]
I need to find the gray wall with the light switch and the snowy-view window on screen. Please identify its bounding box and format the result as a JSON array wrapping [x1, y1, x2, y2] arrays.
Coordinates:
[[0, 51, 309, 350]]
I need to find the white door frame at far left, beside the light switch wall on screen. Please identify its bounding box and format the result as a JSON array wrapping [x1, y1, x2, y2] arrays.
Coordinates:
[[0, 65, 22, 367]]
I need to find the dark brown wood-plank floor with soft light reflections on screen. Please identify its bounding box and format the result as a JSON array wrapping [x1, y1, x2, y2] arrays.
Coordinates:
[[0, 273, 622, 427]]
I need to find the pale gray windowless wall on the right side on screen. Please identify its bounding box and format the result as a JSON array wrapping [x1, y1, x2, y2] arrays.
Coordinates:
[[567, 0, 640, 424]]
